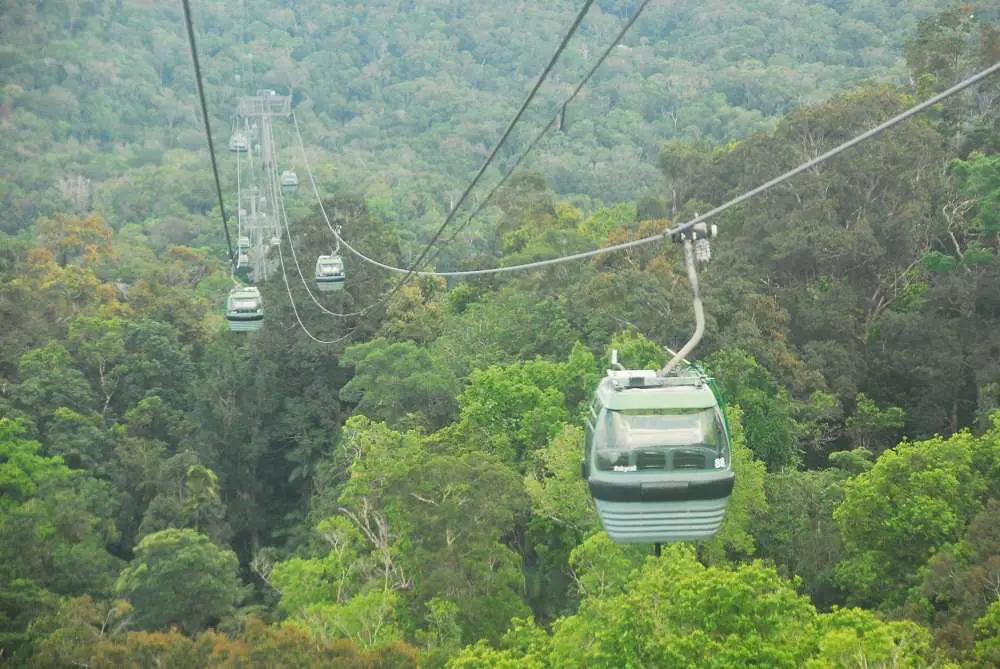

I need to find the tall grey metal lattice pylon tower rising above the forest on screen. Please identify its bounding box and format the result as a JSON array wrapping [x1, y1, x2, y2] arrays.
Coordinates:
[[237, 90, 292, 284]]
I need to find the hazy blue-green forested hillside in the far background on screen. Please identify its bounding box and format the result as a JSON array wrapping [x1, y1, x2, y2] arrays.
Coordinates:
[[0, 0, 964, 243]]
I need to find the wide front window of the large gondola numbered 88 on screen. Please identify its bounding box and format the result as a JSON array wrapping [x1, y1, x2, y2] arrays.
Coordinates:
[[594, 408, 729, 472]]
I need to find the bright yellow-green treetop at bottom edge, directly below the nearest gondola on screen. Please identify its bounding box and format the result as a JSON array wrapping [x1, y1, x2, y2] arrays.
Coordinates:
[[448, 544, 957, 669]]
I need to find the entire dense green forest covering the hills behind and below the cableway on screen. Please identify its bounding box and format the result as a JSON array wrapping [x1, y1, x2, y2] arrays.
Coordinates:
[[0, 0, 1000, 669]]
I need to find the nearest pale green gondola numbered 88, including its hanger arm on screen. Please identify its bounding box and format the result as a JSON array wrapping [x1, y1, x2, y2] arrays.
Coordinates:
[[581, 224, 736, 552]]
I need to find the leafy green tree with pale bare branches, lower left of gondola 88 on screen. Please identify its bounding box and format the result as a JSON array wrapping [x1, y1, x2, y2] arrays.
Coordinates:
[[339, 417, 527, 638]]
